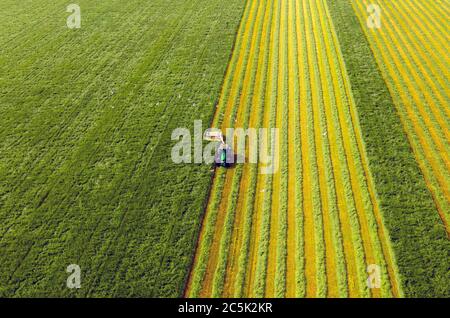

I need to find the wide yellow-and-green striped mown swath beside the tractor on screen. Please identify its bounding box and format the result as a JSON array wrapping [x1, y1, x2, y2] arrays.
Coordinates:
[[186, 0, 402, 297]]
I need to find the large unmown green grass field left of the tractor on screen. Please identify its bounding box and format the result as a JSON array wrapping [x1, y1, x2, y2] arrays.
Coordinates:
[[0, 0, 244, 296]]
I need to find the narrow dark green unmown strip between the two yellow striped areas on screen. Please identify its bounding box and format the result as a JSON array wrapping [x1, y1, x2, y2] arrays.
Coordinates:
[[327, 0, 449, 297]]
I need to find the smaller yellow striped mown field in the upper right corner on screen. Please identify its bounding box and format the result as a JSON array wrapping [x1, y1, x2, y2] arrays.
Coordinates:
[[352, 0, 450, 235]]
